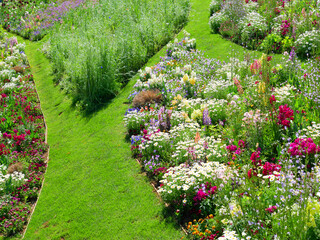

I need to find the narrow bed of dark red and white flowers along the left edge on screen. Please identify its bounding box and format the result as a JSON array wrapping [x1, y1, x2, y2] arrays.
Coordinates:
[[0, 33, 48, 236]]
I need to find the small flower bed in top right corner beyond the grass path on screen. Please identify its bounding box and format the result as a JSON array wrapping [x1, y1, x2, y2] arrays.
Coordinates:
[[209, 0, 320, 58]]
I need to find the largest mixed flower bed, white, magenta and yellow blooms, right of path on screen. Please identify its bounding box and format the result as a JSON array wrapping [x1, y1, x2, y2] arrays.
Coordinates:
[[124, 33, 320, 239]]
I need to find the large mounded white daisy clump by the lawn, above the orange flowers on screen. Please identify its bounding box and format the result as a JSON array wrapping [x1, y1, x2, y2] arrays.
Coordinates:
[[158, 162, 234, 217]]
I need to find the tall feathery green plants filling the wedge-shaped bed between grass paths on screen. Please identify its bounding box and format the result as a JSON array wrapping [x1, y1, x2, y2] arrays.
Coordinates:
[[47, 0, 189, 107]]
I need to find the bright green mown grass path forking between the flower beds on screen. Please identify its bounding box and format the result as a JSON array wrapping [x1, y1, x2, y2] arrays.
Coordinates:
[[1, 0, 282, 240]]
